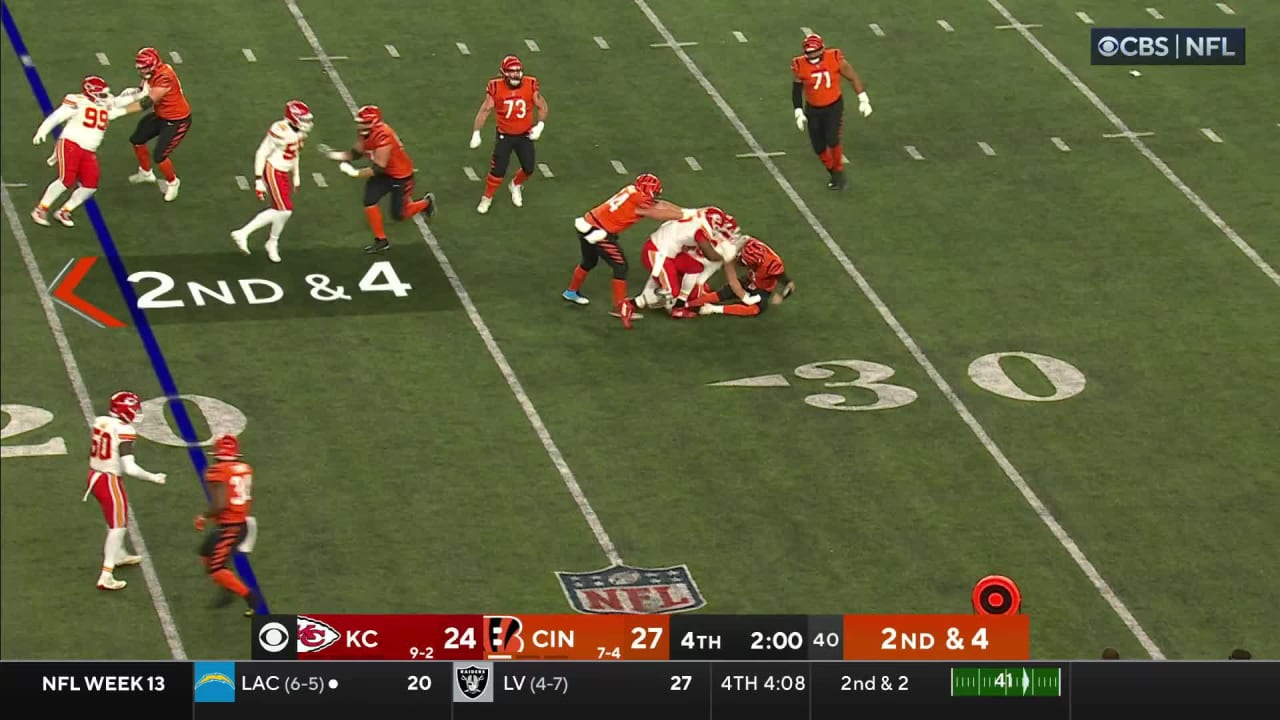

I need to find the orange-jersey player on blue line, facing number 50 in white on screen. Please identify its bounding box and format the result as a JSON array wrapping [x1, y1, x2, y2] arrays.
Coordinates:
[[196, 436, 260, 615]]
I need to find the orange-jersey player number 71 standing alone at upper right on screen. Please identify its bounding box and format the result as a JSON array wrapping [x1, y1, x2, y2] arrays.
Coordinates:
[[791, 33, 872, 190]]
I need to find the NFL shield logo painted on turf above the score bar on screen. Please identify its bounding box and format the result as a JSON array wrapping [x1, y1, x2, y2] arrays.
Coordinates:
[[556, 565, 707, 615]]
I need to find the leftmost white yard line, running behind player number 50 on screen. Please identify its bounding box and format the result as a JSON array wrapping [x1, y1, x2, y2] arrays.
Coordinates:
[[0, 180, 187, 660]]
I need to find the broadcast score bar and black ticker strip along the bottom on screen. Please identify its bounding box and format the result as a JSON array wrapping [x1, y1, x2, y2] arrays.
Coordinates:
[[4, 615, 1280, 720]]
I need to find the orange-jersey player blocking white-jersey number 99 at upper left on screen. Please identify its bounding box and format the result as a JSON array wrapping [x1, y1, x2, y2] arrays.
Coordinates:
[[129, 47, 191, 202]]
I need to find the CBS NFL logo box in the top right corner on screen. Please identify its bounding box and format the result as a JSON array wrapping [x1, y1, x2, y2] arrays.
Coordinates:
[[1089, 27, 1244, 65]]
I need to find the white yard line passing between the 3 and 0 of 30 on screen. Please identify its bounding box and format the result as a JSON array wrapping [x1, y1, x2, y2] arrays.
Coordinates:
[[634, 0, 1164, 659]]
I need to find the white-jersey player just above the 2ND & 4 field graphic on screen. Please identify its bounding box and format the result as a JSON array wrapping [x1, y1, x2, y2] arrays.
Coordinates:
[[232, 100, 315, 263]]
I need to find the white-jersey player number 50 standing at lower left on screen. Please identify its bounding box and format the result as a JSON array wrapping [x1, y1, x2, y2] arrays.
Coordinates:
[[82, 392, 165, 591]]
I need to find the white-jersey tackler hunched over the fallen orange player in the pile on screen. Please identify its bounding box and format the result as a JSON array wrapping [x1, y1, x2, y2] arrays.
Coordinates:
[[620, 206, 746, 328]]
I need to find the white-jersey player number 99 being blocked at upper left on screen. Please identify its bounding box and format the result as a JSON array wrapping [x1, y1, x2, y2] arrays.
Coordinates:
[[31, 76, 141, 227]]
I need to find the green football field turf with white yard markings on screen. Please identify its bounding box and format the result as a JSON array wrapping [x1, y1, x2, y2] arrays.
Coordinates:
[[0, 0, 1280, 659]]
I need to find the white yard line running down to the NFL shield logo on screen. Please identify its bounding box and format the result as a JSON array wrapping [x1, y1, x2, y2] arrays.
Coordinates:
[[284, 0, 622, 565]]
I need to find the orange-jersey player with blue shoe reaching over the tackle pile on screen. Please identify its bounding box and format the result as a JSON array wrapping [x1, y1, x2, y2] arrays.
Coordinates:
[[561, 173, 685, 318]]
